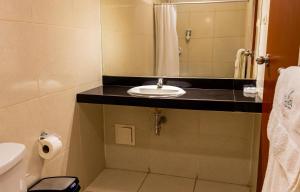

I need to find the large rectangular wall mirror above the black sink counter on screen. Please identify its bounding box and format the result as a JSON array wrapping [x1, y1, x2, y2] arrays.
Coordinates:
[[101, 0, 257, 79]]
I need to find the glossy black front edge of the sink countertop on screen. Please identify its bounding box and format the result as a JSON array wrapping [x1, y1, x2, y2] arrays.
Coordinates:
[[76, 87, 262, 113]]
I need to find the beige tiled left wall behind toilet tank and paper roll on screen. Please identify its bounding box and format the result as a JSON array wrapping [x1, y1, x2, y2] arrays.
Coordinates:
[[0, 0, 103, 189]]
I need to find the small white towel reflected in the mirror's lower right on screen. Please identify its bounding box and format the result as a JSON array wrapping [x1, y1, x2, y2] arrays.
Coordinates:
[[234, 49, 246, 79]]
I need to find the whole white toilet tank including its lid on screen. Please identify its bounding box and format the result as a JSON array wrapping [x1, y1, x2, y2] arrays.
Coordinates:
[[0, 143, 26, 192]]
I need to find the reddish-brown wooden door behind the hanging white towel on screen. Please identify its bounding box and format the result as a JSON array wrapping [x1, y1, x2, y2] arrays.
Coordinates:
[[257, 0, 300, 192]]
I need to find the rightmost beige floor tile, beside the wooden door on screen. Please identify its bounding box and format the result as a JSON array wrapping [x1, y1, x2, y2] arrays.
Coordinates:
[[195, 180, 250, 192]]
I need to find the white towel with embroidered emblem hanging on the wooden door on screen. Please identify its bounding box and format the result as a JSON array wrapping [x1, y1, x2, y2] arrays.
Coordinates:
[[262, 66, 300, 192]]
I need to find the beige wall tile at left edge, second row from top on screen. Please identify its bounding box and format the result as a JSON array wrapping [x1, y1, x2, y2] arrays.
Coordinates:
[[0, 21, 38, 107]]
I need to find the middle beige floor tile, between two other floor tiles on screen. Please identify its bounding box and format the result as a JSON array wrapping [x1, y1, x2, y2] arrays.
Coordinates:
[[140, 174, 194, 192]]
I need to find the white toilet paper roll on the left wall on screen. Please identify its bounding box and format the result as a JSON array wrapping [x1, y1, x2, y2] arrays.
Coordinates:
[[39, 135, 62, 159]]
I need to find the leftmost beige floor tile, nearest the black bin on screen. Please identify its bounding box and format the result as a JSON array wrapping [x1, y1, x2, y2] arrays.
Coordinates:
[[85, 169, 146, 192]]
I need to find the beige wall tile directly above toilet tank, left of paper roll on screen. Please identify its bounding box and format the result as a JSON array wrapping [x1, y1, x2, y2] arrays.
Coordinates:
[[0, 100, 43, 183]]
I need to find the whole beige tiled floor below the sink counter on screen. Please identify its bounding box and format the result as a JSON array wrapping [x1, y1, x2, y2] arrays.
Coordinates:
[[85, 169, 249, 192]]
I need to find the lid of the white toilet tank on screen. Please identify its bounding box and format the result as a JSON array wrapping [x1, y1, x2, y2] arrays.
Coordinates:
[[0, 143, 25, 175]]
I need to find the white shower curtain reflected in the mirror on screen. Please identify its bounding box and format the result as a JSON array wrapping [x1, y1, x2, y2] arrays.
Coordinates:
[[154, 3, 179, 77]]
